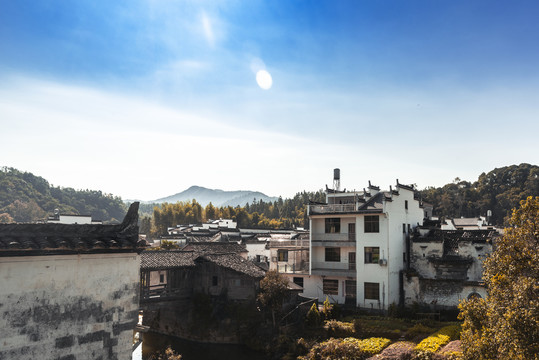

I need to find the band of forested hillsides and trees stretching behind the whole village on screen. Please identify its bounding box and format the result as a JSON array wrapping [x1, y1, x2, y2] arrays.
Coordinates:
[[0, 164, 539, 237]]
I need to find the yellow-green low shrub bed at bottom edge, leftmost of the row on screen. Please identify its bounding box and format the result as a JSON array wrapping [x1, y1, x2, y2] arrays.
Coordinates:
[[299, 338, 391, 360]]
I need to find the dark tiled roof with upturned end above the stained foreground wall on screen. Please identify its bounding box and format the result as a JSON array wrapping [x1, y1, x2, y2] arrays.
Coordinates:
[[0, 202, 146, 256]]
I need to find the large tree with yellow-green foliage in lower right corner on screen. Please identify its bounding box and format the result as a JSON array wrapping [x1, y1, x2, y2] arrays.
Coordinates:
[[460, 196, 539, 360]]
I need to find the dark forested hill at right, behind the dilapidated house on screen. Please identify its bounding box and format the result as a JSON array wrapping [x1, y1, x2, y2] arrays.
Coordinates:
[[421, 164, 539, 226]]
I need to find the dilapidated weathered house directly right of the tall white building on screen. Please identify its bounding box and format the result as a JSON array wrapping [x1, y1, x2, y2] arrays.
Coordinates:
[[403, 227, 497, 309]]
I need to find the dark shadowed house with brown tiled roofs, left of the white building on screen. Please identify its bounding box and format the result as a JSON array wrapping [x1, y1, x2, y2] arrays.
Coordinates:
[[140, 242, 265, 343]]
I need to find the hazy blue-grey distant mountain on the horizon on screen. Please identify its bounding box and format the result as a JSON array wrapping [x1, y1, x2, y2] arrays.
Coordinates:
[[150, 186, 278, 207]]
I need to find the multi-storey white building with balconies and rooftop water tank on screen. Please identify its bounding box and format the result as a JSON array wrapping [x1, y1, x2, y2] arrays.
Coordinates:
[[295, 172, 432, 310]]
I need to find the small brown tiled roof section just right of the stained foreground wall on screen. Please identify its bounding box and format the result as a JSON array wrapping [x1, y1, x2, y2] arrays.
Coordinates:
[[140, 250, 197, 270]]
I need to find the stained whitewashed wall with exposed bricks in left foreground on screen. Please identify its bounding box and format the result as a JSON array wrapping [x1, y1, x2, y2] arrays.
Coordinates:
[[0, 253, 140, 360]]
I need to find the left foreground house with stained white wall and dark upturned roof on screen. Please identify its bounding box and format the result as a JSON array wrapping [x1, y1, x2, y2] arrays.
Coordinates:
[[0, 203, 145, 360]]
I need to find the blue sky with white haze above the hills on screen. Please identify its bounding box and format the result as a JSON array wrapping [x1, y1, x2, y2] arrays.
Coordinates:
[[0, 0, 539, 200]]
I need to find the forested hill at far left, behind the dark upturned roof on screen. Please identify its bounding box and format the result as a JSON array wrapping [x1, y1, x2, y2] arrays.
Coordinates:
[[0, 167, 127, 223]]
